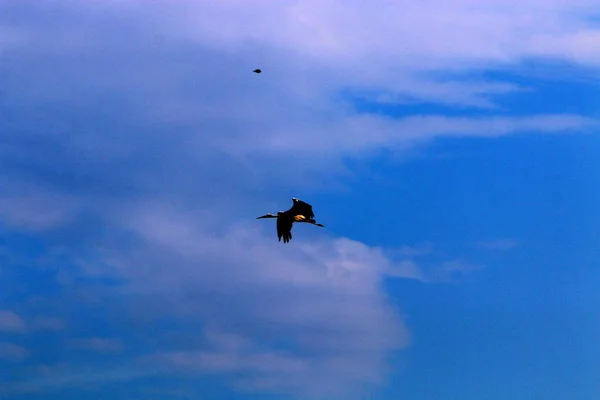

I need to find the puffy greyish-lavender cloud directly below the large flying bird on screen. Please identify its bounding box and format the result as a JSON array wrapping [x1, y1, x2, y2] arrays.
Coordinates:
[[56, 208, 410, 395]]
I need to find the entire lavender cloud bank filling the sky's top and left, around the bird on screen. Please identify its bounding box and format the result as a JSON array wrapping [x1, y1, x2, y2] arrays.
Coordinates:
[[0, 0, 600, 398]]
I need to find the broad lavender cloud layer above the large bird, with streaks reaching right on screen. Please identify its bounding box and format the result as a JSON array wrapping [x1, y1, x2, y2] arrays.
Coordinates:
[[0, 1, 598, 209]]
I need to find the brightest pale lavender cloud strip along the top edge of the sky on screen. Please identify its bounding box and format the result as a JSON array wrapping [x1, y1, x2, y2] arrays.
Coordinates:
[[144, 0, 597, 69]]
